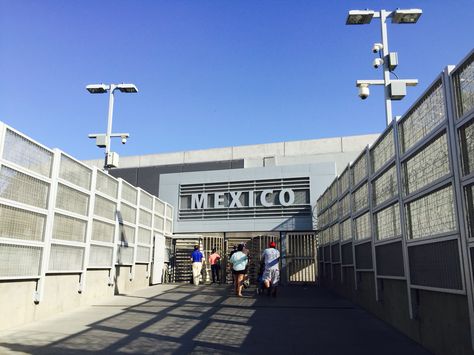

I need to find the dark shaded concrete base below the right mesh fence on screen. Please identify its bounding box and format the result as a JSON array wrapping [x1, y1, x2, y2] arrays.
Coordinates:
[[319, 270, 474, 355]]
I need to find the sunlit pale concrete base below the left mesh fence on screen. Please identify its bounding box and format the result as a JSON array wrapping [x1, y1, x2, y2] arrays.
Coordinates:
[[0, 265, 149, 330]]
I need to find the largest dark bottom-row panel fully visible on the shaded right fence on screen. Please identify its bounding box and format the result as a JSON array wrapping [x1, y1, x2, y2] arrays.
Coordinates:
[[408, 239, 462, 290]]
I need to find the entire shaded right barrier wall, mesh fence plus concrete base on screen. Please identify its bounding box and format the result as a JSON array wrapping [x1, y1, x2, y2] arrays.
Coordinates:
[[317, 52, 474, 354]]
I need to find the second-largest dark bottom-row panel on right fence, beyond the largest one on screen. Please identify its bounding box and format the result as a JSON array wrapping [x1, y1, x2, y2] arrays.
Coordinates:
[[375, 242, 405, 277]]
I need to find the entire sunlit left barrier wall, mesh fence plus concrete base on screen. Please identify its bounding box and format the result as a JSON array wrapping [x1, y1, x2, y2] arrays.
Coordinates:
[[0, 122, 173, 329]]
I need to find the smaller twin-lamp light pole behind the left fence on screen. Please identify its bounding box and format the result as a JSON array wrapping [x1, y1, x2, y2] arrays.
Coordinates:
[[86, 83, 138, 173]]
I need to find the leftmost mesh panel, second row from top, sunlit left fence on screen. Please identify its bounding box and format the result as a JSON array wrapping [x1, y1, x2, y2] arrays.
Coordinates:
[[0, 166, 49, 209]]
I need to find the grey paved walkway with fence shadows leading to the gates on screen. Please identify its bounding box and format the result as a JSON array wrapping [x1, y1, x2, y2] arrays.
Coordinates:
[[0, 285, 429, 355]]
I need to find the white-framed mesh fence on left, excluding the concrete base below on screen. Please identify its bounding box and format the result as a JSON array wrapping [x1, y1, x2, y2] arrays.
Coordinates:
[[0, 122, 173, 286]]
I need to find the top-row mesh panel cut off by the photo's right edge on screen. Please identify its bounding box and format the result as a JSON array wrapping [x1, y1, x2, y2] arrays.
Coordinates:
[[453, 55, 474, 118]]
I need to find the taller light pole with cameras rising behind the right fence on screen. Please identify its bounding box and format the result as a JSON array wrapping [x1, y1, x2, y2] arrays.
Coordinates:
[[346, 9, 423, 126]]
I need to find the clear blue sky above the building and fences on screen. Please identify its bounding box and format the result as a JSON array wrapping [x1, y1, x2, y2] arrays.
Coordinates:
[[0, 0, 474, 159]]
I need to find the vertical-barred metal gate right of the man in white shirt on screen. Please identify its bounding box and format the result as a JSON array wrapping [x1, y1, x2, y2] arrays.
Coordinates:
[[286, 232, 317, 283]]
